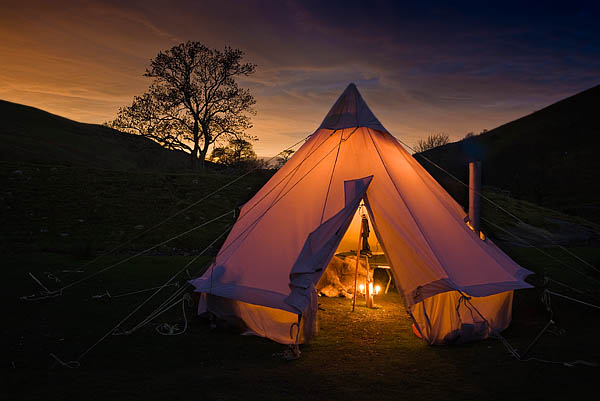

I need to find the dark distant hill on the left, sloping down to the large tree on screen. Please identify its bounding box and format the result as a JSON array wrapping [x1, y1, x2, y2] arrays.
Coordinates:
[[0, 100, 189, 171]]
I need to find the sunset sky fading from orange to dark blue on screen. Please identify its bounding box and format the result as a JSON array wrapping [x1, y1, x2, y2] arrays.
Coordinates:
[[0, 0, 600, 156]]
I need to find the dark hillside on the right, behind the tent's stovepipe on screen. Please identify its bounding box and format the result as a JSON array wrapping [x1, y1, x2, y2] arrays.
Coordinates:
[[415, 85, 600, 222]]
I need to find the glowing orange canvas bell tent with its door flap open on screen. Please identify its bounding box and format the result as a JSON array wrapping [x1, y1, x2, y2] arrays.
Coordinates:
[[191, 84, 531, 344]]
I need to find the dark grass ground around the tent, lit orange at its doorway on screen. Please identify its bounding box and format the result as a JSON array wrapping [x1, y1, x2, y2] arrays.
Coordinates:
[[1, 163, 600, 400]]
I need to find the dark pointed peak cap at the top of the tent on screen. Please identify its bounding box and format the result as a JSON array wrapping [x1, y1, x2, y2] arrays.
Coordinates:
[[319, 84, 388, 132]]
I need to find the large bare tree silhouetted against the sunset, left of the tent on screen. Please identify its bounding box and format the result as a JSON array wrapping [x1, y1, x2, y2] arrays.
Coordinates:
[[107, 41, 256, 168]]
